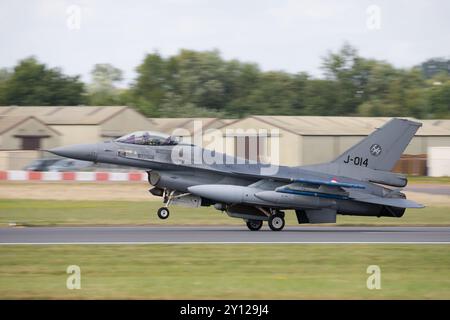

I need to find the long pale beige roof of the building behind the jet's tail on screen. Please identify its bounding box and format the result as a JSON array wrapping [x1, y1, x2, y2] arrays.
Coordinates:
[[223, 116, 450, 136]]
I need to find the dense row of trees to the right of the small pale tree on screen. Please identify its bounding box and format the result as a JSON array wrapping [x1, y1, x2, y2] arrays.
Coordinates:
[[124, 44, 449, 117]]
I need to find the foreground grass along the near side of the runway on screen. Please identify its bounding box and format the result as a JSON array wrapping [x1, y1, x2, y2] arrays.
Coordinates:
[[0, 245, 450, 299]]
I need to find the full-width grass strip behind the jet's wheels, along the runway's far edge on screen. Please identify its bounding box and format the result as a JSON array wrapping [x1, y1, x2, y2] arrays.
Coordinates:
[[0, 200, 450, 227]]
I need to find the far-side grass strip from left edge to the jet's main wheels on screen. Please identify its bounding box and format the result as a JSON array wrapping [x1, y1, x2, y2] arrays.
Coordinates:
[[0, 200, 243, 226]]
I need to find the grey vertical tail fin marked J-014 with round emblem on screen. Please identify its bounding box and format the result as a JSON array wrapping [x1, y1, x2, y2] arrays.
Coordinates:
[[333, 118, 422, 171]]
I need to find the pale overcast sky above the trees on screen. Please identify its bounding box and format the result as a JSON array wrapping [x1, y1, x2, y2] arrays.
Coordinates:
[[0, 0, 450, 83]]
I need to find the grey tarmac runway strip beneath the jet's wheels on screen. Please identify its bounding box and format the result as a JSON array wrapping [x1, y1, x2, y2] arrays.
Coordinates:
[[0, 226, 450, 245]]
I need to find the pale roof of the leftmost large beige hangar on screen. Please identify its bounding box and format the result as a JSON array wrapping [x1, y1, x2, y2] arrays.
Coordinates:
[[0, 106, 127, 125]]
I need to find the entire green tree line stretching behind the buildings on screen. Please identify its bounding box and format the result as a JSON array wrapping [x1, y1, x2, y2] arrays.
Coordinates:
[[0, 44, 450, 118]]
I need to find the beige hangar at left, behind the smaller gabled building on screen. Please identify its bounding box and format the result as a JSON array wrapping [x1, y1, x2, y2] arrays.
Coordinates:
[[0, 106, 151, 145]]
